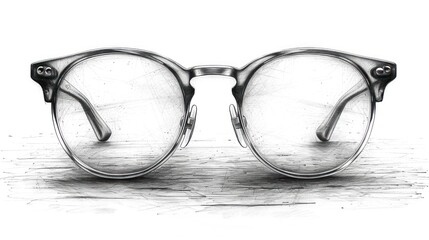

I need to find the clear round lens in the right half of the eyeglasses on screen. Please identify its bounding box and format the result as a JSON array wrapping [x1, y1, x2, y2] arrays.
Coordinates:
[[241, 54, 372, 175]]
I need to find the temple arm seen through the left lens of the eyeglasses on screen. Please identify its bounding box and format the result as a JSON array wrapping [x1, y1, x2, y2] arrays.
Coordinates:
[[59, 80, 112, 142]]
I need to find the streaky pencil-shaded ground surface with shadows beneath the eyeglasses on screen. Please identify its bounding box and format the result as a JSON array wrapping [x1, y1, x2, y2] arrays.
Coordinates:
[[0, 134, 429, 215]]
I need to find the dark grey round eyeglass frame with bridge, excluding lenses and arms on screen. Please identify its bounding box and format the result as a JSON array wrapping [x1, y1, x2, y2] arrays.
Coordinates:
[[31, 48, 396, 179]]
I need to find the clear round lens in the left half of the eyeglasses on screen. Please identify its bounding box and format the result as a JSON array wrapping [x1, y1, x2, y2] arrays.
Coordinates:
[[54, 53, 185, 175]]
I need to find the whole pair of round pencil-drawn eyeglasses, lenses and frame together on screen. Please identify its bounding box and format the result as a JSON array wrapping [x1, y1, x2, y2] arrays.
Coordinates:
[[31, 48, 396, 179]]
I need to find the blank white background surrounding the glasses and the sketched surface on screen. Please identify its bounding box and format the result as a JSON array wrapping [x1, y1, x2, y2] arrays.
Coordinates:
[[0, 0, 429, 239]]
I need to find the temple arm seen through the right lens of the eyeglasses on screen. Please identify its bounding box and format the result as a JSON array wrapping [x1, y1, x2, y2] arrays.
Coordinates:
[[316, 81, 368, 142]]
